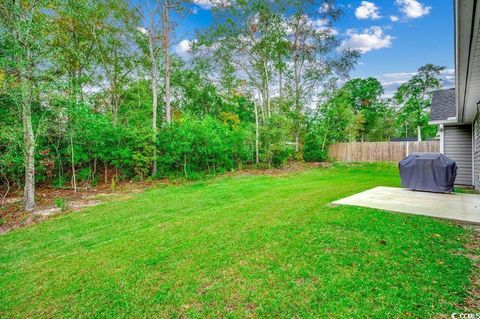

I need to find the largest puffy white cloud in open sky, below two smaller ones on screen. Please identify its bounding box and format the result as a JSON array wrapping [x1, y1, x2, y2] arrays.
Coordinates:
[[340, 27, 394, 53]]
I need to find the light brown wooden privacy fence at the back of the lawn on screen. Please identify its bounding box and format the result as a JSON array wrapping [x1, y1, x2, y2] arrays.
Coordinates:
[[328, 141, 440, 162]]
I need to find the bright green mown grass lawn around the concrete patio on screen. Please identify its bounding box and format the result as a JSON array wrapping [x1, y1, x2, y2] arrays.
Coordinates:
[[0, 164, 472, 318]]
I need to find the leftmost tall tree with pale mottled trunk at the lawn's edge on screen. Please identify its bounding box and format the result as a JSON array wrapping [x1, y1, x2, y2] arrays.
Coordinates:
[[0, 0, 51, 211]]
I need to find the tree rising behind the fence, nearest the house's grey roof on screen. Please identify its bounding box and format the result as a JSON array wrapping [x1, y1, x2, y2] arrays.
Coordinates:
[[394, 64, 445, 141]]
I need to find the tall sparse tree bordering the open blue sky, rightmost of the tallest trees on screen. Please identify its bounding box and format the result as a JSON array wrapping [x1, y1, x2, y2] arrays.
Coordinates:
[[286, 1, 359, 152]]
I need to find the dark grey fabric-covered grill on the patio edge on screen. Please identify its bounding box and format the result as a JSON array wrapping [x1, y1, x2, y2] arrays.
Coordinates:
[[398, 153, 457, 193]]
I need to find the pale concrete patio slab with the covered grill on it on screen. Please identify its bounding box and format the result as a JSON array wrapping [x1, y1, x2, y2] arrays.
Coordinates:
[[333, 186, 480, 223]]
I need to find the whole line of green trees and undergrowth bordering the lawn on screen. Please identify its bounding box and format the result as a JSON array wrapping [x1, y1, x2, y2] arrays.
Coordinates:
[[0, 0, 444, 210]]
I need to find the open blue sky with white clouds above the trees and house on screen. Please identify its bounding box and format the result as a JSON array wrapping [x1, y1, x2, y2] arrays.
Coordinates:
[[174, 0, 454, 95]]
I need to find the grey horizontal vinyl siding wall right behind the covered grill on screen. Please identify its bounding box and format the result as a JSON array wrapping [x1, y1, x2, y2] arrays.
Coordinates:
[[444, 125, 473, 185]]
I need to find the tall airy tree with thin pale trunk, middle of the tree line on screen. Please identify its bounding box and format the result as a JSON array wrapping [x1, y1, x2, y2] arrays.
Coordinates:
[[199, 0, 286, 163]]
